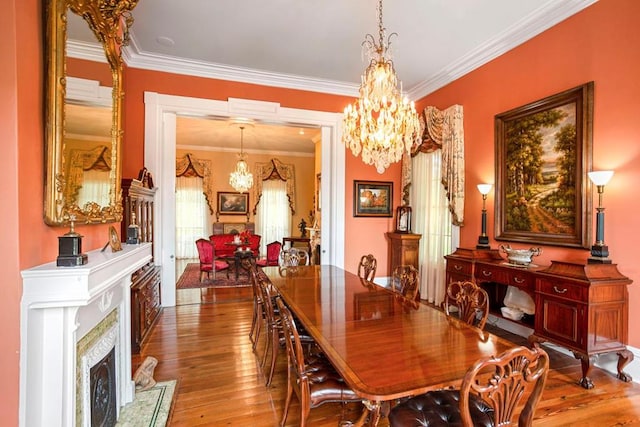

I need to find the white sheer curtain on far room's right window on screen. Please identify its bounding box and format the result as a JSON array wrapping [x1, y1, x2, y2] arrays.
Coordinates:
[[256, 179, 291, 254]]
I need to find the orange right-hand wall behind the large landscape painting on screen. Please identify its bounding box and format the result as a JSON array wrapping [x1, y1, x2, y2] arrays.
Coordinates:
[[420, 0, 640, 347]]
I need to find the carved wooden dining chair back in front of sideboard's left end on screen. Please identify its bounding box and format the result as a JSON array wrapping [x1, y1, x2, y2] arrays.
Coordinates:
[[442, 281, 489, 329]]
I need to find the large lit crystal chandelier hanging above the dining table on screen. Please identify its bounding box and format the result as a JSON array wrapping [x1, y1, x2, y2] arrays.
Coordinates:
[[342, 0, 420, 174]]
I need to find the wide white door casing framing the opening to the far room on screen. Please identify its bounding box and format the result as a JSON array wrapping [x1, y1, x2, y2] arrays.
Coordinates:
[[144, 92, 345, 307]]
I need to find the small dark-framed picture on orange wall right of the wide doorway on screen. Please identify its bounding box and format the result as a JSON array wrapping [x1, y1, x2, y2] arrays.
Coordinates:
[[353, 180, 393, 217]]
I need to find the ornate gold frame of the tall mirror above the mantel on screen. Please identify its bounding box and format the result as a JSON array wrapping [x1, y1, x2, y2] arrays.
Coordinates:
[[44, 0, 138, 225]]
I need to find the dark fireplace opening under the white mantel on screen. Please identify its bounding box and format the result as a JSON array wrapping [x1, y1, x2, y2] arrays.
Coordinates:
[[89, 347, 118, 427]]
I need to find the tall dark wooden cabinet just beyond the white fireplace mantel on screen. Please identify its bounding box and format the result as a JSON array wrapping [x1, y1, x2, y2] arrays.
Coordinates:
[[120, 179, 162, 354]]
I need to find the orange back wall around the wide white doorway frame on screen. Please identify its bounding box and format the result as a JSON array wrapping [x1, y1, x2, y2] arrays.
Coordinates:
[[123, 68, 400, 271]]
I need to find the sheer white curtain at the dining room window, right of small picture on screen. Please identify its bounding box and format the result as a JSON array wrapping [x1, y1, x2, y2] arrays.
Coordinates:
[[410, 150, 460, 305]]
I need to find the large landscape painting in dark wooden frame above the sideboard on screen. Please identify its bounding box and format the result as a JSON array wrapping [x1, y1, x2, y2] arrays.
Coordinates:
[[495, 82, 593, 248]]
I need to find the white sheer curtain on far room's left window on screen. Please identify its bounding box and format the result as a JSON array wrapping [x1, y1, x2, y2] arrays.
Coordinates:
[[176, 176, 208, 259]]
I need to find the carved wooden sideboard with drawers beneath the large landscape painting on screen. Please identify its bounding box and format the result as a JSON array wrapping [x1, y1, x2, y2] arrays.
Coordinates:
[[445, 248, 633, 389]]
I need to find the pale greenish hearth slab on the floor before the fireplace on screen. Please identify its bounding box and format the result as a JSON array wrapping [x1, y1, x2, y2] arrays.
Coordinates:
[[116, 380, 176, 427]]
